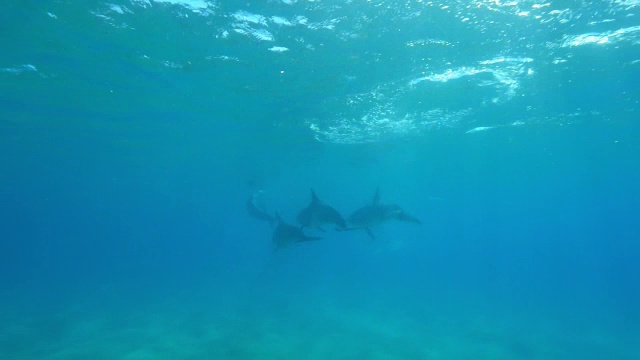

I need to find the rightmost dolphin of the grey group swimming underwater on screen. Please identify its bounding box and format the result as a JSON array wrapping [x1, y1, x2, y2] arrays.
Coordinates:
[[348, 189, 422, 238]]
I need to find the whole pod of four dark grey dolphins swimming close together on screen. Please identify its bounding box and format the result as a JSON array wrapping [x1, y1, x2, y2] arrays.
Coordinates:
[[247, 189, 422, 249]]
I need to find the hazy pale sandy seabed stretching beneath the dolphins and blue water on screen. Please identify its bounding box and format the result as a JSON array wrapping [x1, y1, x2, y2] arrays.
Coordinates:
[[0, 291, 640, 360]]
